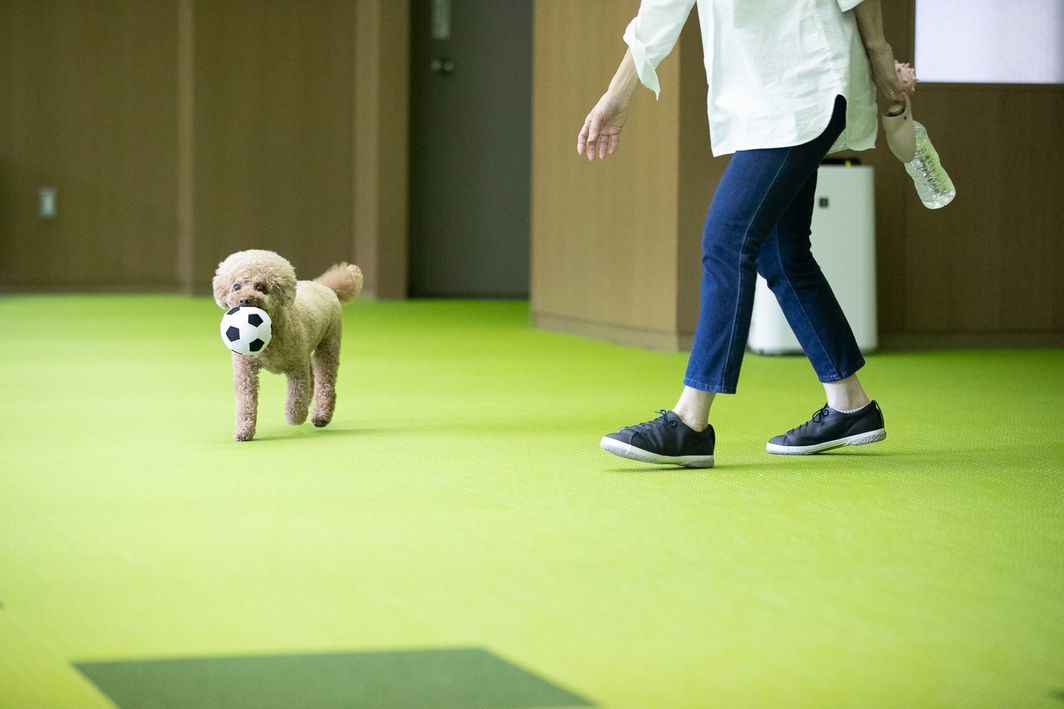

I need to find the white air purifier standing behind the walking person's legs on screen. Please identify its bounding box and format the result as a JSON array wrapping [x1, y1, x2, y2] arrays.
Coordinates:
[[748, 162, 879, 355]]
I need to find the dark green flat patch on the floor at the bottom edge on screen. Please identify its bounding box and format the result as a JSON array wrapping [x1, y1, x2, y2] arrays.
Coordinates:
[[74, 648, 592, 709]]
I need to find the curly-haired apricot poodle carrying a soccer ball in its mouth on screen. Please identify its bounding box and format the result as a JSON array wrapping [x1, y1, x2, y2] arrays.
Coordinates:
[[214, 249, 362, 441]]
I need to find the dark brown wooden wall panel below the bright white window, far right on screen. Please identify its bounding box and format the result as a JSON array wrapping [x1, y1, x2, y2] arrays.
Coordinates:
[[904, 84, 1064, 343]]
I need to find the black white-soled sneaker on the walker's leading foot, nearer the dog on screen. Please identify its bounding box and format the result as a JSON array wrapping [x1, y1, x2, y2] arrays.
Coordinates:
[[599, 411, 714, 467]]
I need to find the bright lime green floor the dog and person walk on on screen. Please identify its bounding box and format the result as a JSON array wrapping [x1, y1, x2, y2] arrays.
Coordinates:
[[0, 296, 1064, 709]]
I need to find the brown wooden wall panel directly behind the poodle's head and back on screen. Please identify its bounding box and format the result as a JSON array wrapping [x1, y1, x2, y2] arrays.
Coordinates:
[[193, 0, 354, 288]]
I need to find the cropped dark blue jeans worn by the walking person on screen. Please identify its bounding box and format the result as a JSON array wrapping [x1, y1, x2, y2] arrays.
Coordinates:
[[684, 96, 864, 394]]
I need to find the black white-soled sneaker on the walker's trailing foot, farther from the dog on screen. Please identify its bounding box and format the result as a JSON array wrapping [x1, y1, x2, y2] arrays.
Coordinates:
[[765, 401, 886, 456]]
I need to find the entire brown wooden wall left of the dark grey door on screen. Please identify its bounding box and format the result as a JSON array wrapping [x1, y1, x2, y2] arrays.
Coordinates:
[[0, 0, 409, 297]]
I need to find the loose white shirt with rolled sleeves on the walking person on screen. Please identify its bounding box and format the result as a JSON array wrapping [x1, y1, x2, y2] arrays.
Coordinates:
[[625, 0, 878, 155]]
